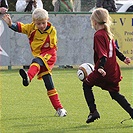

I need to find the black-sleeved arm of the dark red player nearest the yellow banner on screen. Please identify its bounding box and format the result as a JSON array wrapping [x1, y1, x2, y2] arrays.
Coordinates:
[[116, 47, 131, 65]]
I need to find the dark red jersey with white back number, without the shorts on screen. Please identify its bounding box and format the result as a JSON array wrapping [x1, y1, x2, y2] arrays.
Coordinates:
[[94, 30, 120, 82]]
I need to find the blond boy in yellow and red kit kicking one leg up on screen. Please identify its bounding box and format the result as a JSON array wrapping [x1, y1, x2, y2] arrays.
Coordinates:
[[3, 8, 67, 116]]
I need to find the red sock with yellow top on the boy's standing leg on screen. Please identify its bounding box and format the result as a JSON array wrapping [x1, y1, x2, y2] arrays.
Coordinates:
[[47, 89, 63, 110]]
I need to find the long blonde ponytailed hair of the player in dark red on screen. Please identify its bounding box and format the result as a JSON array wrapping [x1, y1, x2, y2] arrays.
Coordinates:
[[90, 8, 114, 39]]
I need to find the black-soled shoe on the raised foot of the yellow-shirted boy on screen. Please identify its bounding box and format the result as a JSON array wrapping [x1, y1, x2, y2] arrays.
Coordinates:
[[19, 69, 30, 86]]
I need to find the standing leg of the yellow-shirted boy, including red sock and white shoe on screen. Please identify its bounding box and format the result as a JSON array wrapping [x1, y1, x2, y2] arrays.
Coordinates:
[[42, 74, 67, 116]]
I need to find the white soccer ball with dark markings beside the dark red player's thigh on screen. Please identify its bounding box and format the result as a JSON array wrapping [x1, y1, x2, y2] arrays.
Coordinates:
[[77, 63, 94, 81]]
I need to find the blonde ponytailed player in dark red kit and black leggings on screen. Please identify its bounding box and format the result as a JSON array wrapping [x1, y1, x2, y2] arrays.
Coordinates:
[[83, 8, 133, 123]]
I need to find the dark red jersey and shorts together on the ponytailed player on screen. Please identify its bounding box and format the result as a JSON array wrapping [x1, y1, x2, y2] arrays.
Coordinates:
[[87, 29, 121, 91]]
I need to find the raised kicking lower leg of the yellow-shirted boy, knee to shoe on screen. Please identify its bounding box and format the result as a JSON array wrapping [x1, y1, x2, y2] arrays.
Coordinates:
[[19, 58, 41, 86]]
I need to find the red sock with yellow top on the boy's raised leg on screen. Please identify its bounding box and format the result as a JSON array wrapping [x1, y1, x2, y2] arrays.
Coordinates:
[[27, 63, 40, 81]]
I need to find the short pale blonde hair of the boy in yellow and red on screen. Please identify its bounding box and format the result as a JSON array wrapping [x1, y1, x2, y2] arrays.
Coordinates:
[[32, 8, 49, 22]]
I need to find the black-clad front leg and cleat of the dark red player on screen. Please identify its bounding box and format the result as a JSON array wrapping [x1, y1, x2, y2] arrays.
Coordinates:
[[83, 82, 100, 123]]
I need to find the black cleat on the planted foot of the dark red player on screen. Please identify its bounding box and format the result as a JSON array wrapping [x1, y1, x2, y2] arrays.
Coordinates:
[[86, 110, 100, 123]]
